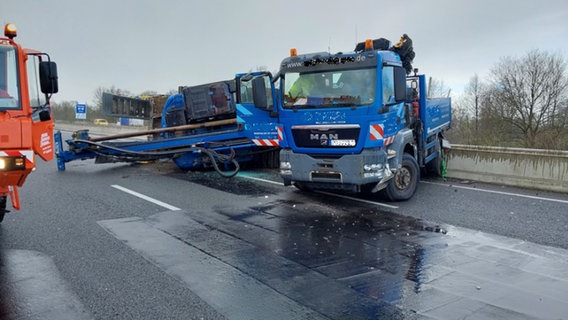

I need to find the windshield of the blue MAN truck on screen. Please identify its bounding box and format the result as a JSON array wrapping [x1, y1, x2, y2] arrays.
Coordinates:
[[282, 68, 376, 108]]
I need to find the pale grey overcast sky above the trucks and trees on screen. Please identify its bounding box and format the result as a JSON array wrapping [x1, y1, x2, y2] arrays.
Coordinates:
[[0, 0, 568, 103]]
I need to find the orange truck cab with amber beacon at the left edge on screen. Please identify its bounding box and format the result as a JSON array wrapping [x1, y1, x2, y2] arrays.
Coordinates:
[[0, 24, 58, 222]]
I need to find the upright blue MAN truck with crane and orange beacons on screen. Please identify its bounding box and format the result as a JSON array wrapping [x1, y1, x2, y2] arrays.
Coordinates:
[[255, 35, 451, 201]]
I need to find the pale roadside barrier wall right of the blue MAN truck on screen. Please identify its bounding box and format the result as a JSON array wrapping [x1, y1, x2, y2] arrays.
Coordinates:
[[447, 145, 568, 193]]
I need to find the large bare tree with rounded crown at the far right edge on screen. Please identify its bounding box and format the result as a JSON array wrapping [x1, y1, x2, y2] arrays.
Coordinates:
[[491, 50, 568, 148]]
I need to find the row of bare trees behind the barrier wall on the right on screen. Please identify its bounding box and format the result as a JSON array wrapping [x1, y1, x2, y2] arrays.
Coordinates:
[[448, 50, 568, 150]]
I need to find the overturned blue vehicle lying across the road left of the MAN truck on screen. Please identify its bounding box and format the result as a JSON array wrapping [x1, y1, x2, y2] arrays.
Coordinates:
[[55, 72, 279, 177]]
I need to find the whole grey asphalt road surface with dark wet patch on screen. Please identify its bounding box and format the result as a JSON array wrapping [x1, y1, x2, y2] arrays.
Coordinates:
[[0, 154, 568, 319]]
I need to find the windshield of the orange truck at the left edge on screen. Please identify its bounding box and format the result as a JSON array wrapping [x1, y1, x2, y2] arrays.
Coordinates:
[[0, 45, 21, 111]]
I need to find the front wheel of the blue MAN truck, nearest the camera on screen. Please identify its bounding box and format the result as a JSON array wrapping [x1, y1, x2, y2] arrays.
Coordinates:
[[384, 153, 420, 201]]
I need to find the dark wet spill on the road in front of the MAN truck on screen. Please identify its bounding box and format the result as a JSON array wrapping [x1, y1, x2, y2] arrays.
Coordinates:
[[210, 196, 447, 319]]
